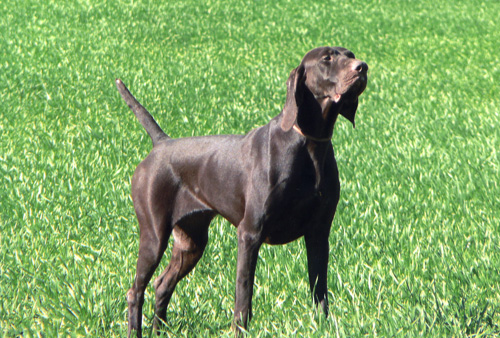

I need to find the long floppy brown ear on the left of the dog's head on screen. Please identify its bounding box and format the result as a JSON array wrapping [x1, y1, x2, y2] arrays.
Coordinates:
[[281, 64, 305, 131]]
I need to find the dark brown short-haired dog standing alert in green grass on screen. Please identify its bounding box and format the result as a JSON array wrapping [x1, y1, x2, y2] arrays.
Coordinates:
[[116, 47, 368, 337]]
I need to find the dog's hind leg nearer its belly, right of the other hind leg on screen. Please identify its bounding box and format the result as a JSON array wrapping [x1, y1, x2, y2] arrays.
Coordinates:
[[154, 211, 215, 331]]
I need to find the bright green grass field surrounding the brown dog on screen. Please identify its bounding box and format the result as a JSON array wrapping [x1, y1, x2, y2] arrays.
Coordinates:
[[0, 0, 500, 337]]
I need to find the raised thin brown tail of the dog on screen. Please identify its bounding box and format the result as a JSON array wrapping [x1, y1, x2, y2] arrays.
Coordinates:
[[116, 79, 169, 147]]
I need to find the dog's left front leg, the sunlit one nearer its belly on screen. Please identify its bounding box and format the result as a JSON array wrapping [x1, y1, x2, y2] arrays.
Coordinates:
[[234, 226, 262, 337]]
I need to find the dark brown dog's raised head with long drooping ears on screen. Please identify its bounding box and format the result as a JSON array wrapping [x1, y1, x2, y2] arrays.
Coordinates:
[[281, 47, 368, 131]]
